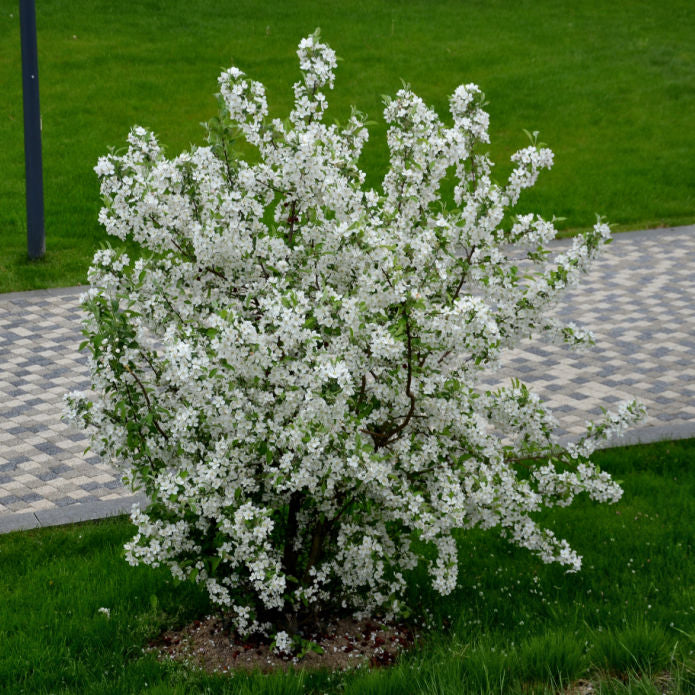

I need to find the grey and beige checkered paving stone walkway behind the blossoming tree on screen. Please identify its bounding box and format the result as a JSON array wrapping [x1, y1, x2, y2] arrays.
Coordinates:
[[0, 225, 695, 532]]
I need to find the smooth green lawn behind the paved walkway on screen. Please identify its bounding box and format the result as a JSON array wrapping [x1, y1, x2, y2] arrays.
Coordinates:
[[0, 0, 695, 292]]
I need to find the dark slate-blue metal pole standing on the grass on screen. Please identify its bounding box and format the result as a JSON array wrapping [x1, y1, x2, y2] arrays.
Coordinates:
[[19, 0, 46, 258]]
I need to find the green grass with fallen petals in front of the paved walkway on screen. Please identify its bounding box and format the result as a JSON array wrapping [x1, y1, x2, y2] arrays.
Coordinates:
[[0, 440, 695, 695]]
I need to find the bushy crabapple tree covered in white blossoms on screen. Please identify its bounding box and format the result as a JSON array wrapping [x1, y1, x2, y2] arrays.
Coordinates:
[[66, 33, 643, 649]]
